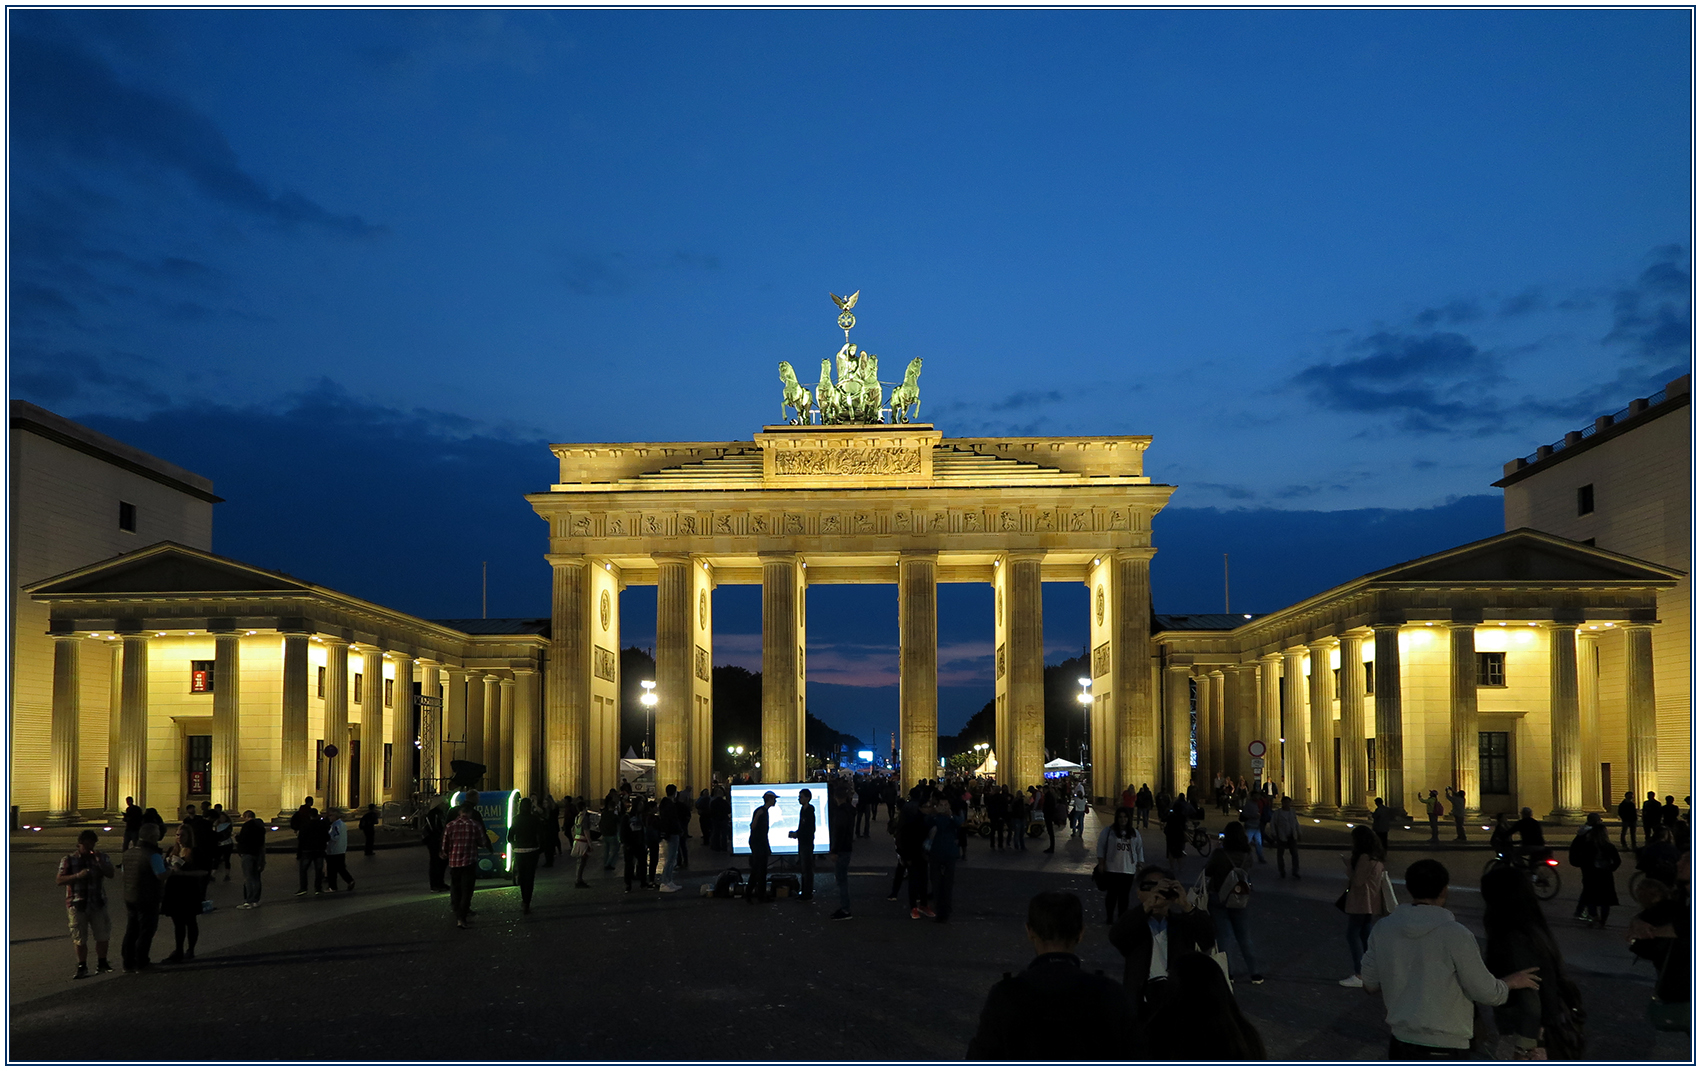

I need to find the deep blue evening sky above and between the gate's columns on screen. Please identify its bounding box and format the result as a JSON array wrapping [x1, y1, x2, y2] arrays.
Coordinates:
[[9, 10, 1691, 748]]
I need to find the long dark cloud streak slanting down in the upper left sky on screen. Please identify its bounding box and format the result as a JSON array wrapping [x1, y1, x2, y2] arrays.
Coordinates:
[[9, 34, 384, 238]]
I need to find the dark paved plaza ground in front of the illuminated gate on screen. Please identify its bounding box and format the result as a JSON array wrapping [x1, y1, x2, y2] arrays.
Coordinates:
[[7, 814, 1689, 1063]]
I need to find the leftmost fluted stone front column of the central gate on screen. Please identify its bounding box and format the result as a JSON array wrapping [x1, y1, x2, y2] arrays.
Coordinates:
[[544, 556, 592, 799]]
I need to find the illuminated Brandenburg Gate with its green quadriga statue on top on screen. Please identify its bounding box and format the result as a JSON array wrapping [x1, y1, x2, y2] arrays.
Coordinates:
[[527, 294, 1174, 797]]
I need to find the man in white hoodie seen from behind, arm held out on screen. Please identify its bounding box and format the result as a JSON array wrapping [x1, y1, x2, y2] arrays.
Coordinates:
[[1361, 859, 1541, 1061]]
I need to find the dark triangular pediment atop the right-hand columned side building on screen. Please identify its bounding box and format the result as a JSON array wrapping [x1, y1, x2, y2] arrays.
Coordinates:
[[1364, 529, 1684, 587]]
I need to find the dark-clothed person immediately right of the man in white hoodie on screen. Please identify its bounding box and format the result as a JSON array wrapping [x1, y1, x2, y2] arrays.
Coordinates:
[[1482, 870, 1585, 1059]]
